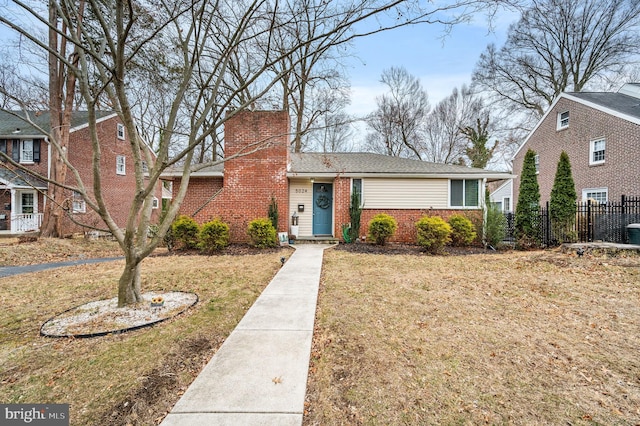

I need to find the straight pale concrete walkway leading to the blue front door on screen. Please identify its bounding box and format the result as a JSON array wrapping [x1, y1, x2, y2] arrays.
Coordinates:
[[161, 244, 330, 426]]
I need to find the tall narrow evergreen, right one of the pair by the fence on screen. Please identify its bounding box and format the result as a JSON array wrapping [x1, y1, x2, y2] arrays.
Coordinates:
[[549, 151, 578, 241]]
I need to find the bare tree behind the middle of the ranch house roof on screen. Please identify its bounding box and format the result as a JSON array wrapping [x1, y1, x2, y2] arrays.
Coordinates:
[[367, 67, 430, 160]]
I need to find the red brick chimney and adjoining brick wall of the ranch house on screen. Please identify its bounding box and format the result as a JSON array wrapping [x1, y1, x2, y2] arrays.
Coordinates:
[[173, 111, 289, 242]]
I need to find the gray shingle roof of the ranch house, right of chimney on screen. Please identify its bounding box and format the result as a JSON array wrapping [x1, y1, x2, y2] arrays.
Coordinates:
[[289, 152, 509, 178]]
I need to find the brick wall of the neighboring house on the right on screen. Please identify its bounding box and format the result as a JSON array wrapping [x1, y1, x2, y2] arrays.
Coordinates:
[[513, 98, 640, 206]]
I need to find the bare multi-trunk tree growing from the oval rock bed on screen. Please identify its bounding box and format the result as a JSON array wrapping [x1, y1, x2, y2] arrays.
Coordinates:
[[0, 0, 510, 306]]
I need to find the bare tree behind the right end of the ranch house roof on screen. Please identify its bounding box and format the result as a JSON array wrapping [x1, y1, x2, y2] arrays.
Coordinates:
[[423, 85, 483, 164]]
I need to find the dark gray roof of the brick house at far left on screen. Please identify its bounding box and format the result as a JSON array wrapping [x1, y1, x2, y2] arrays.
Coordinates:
[[0, 111, 115, 139]]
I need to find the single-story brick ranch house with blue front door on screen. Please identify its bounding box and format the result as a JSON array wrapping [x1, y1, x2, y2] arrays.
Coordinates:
[[163, 111, 512, 242]]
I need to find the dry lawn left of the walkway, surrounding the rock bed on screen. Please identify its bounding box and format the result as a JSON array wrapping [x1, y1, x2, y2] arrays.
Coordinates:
[[0, 251, 289, 425]]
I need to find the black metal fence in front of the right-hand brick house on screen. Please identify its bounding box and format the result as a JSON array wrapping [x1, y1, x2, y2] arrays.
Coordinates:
[[506, 195, 640, 246]]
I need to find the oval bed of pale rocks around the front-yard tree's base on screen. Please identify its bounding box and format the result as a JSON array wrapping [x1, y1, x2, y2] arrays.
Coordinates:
[[40, 291, 198, 338]]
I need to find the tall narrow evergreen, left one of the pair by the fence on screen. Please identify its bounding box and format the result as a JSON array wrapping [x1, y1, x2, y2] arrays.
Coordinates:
[[515, 150, 540, 248]]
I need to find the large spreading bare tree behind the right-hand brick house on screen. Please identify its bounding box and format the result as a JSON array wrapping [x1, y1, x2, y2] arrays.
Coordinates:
[[473, 0, 640, 119]]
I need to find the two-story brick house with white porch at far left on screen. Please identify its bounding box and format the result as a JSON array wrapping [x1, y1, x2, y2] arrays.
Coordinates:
[[0, 111, 162, 234]]
